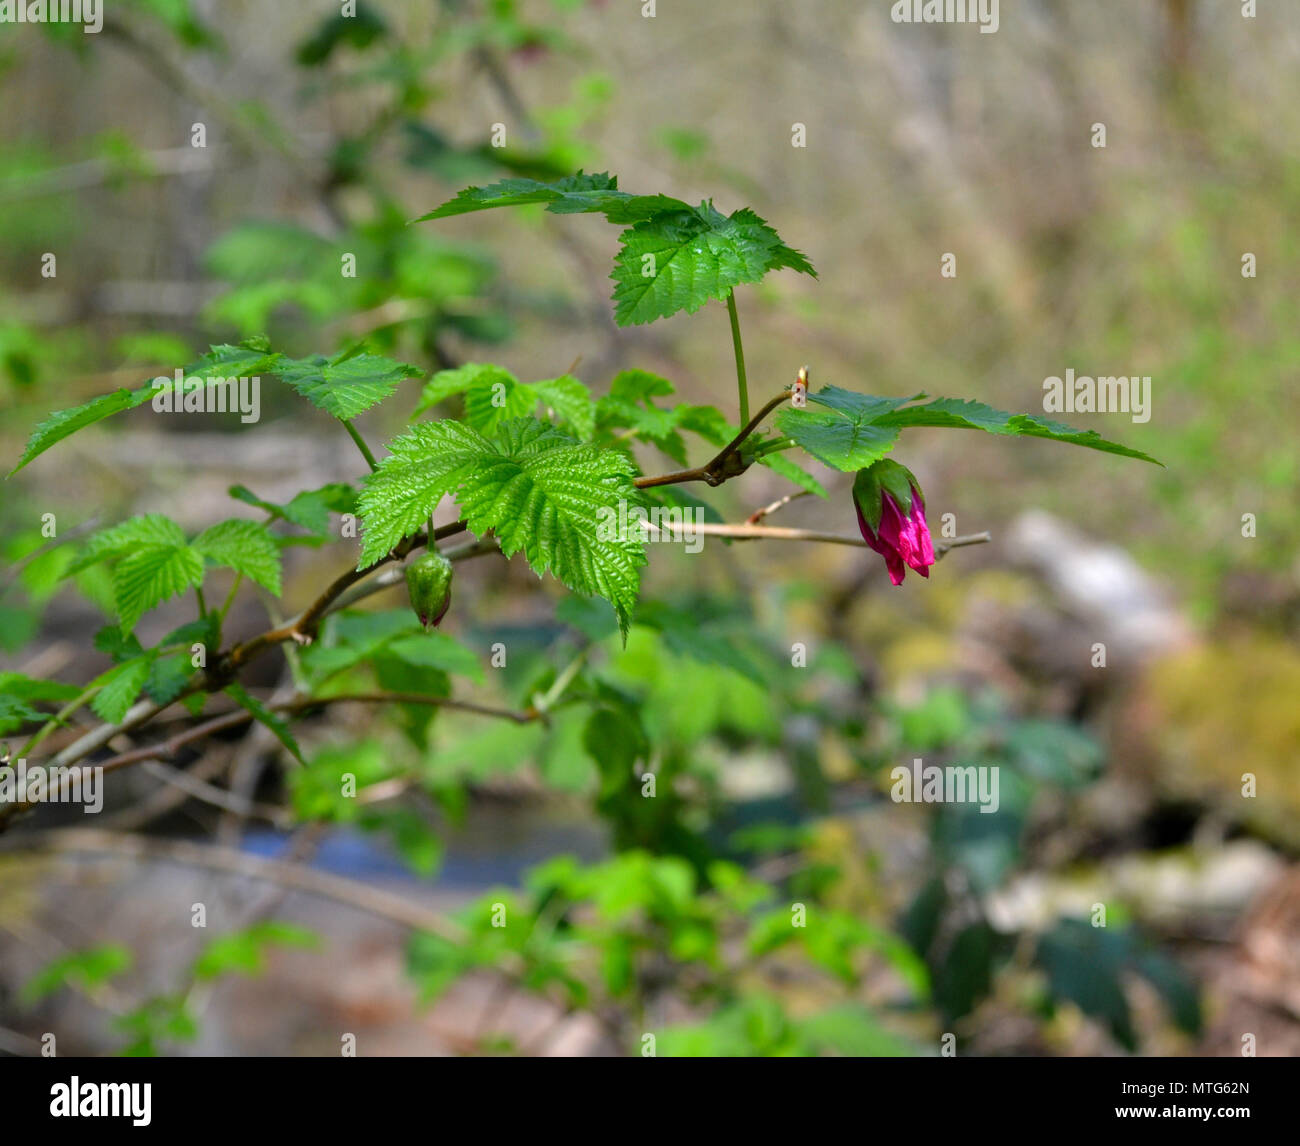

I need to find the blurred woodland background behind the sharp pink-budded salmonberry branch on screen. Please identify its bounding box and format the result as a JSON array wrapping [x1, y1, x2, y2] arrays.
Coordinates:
[[0, 0, 1300, 1055]]
